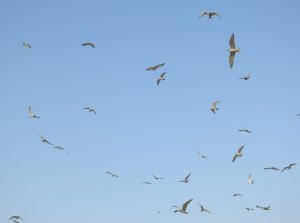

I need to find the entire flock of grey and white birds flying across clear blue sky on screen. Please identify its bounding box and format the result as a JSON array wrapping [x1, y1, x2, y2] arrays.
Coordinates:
[[9, 7, 300, 223]]
